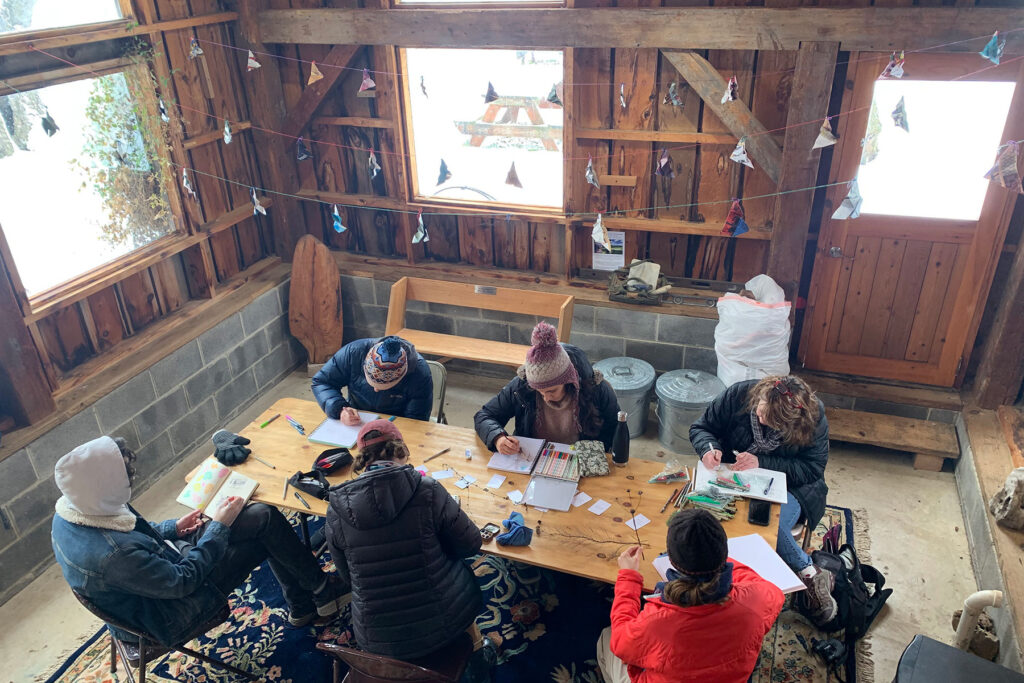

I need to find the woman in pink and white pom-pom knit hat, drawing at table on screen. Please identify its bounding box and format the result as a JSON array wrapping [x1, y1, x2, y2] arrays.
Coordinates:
[[473, 323, 618, 454]]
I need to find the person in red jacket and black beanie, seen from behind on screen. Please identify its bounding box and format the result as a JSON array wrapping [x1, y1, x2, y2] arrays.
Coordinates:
[[597, 510, 783, 683]]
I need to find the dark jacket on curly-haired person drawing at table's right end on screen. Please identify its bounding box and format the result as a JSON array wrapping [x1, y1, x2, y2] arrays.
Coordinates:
[[690, 380, 828, 527]]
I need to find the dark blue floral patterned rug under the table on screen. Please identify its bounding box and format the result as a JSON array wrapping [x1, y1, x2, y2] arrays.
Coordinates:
[[45, 506, 873, 683]]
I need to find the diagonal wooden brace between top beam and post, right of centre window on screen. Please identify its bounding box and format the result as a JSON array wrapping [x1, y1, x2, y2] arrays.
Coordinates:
[[663, 50, 778, 183]]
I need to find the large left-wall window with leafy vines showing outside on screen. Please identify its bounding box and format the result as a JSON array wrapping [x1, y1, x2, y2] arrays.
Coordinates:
[[0, 67, 174, 296]]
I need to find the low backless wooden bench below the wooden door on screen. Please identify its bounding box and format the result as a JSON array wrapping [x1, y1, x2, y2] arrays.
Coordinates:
[[825, 408, 959, 472]]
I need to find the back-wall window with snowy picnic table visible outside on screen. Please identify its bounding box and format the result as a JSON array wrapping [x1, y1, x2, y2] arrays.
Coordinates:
[[403, 48, 562, 208]]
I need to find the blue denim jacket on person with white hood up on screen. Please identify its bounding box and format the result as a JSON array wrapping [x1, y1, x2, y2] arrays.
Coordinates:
[[51, 498, 230, 646]]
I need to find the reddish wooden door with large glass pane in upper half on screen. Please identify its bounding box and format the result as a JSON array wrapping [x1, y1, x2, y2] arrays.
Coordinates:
[[799, 53, 1024, 386]]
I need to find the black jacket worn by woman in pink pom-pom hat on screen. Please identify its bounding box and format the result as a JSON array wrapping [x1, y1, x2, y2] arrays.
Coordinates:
[[473, 344, 618, 451]]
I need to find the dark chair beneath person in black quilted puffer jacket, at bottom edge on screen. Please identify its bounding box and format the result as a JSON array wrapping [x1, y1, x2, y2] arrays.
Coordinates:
[[316, 634, 473, 683]]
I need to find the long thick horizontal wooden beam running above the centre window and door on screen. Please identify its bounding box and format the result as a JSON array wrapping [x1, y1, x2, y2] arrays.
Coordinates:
[[253, 3, 1024, 54]]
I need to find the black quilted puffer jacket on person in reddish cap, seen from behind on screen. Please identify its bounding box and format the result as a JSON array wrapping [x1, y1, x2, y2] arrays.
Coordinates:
[[327, 465, 483, 659]]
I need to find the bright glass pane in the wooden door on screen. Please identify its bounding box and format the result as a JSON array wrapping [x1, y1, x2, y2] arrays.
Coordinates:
[[857, 79, 1015, 220]]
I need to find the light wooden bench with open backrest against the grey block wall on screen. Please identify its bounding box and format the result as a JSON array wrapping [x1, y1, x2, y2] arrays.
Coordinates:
[[385, 278, 573, 368]]
